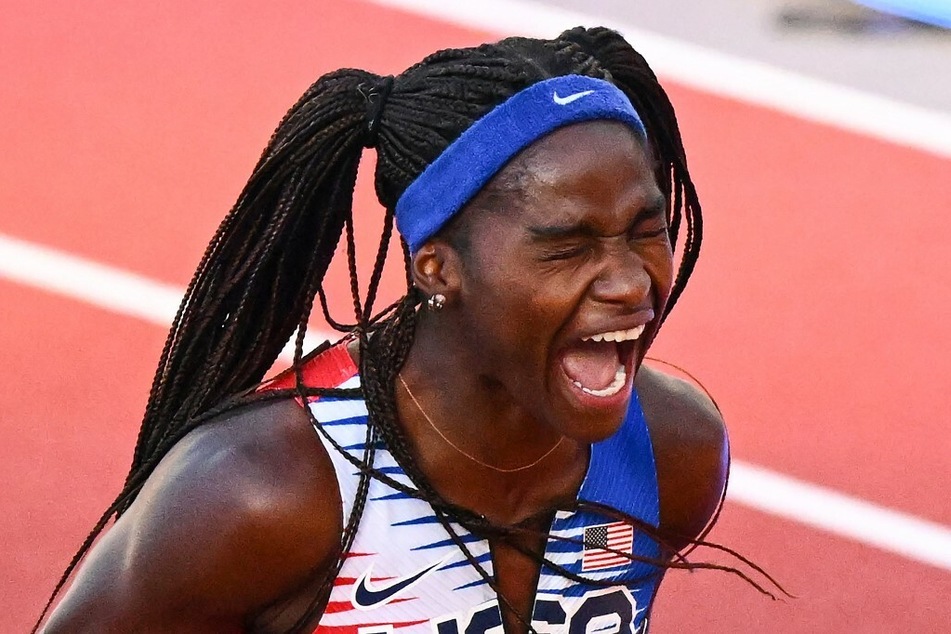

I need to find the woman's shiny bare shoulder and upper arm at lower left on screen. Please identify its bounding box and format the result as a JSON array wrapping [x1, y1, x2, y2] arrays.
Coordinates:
[[47, 403, 341, 632]]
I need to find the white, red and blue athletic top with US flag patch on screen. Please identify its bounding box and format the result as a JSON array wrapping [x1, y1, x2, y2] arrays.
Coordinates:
[[272, 345, 663, 634]]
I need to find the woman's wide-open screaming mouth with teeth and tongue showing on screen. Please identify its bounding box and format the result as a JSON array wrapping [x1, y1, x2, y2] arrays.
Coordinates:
[[561, 325, 645, 398]]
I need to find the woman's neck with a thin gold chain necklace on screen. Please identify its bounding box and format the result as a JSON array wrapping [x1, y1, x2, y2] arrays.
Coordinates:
[[396, 315, 588, 523]]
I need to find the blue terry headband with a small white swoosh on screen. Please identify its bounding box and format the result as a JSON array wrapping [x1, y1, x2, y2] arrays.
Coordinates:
[[396, 75, 647, 253]]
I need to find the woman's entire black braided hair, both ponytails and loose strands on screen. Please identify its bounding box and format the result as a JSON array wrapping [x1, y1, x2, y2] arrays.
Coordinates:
[[37, 27, 780, 631]]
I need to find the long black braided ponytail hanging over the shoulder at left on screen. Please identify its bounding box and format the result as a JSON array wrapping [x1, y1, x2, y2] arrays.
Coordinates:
[[37, 65, 384, 626]]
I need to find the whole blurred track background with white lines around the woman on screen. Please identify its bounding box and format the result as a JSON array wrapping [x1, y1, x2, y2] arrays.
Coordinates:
[[0, 0, 951, 634]]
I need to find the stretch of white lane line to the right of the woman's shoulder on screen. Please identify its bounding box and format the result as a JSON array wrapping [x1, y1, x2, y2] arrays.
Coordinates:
[[727, 462, 951, 571]]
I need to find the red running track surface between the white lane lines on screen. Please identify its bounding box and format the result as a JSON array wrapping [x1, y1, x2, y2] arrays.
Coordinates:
[[0, 0, 951, 634]]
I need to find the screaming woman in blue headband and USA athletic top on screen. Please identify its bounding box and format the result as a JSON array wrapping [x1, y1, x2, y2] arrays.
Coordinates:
[[37, 28, 728, 634]]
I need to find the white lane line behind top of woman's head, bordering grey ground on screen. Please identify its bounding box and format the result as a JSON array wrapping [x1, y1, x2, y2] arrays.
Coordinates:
[[370, 0, 951, 157]]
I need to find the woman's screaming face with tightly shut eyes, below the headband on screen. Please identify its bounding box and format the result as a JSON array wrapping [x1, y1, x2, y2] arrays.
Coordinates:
[[453, 121, 673, 442]]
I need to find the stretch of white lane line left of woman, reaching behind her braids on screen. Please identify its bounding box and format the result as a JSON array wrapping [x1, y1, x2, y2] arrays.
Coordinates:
[[0, 234, 338, 363]]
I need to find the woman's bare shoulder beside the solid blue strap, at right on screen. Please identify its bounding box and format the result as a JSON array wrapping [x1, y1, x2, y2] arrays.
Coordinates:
[[637, 365, 729, 547]]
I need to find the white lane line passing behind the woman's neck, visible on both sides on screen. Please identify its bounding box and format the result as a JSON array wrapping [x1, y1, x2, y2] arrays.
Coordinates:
[[0, 234, 951, 570]]
